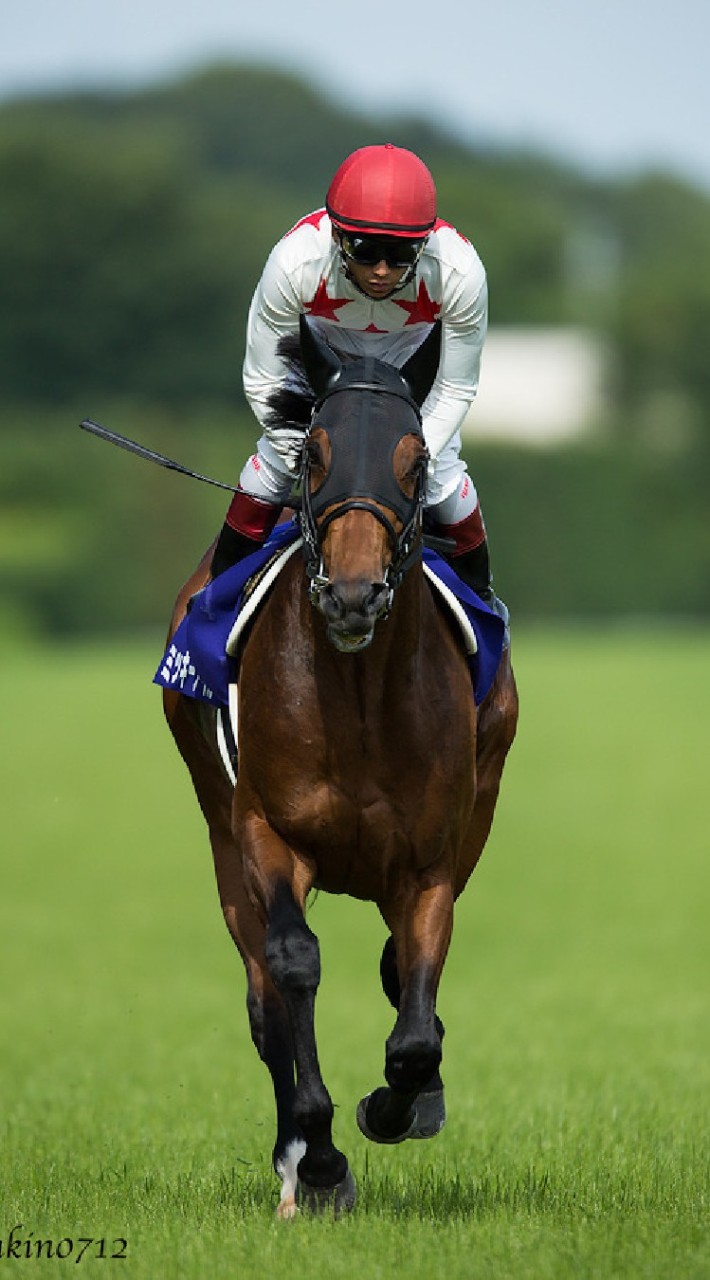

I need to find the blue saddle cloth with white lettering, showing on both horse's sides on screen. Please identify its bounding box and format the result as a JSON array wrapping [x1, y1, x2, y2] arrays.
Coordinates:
[[154, 521, 505, 707]]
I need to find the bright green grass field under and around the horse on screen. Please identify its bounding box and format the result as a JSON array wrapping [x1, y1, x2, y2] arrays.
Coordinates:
[[0, 630, 710, 1280]]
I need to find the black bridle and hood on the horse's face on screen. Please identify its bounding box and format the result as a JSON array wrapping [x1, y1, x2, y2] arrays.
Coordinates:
[[298, 366, 426, 617]]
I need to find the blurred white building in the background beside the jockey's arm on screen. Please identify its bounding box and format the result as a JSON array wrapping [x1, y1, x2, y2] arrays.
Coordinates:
[[462, 328, 608, 445]]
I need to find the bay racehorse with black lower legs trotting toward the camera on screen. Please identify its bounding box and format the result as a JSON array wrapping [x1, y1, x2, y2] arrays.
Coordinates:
[[164, 317, 518, 1219]]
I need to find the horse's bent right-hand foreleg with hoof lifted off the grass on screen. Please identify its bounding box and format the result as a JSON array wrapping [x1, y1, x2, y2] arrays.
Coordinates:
[[357, 882, 453, 1142]]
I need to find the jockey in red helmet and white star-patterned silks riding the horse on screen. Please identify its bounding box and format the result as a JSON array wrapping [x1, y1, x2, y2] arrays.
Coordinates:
[[211, 143, 505, 612]]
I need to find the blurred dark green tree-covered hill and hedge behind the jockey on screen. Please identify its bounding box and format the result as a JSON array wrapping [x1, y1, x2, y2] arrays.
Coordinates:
[[0, 65, 710, 637]]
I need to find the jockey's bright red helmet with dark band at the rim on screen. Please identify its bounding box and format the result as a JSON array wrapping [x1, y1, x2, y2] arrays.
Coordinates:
[[325, 142, 436, 239]]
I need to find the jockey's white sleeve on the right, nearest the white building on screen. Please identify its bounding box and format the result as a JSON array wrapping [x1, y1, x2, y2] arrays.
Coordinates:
[[422, 272, 487, 461]]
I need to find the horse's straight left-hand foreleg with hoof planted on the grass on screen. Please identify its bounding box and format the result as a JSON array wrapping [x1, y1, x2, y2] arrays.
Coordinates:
[[243, 824, 354, 1211]]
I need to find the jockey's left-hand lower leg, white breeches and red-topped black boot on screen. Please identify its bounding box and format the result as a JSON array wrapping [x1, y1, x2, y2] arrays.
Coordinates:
[[211, 438, 298, 577]]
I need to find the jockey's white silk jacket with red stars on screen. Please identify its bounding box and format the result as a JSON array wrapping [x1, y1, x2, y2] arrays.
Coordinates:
[[243, 209, 487, 476]]
